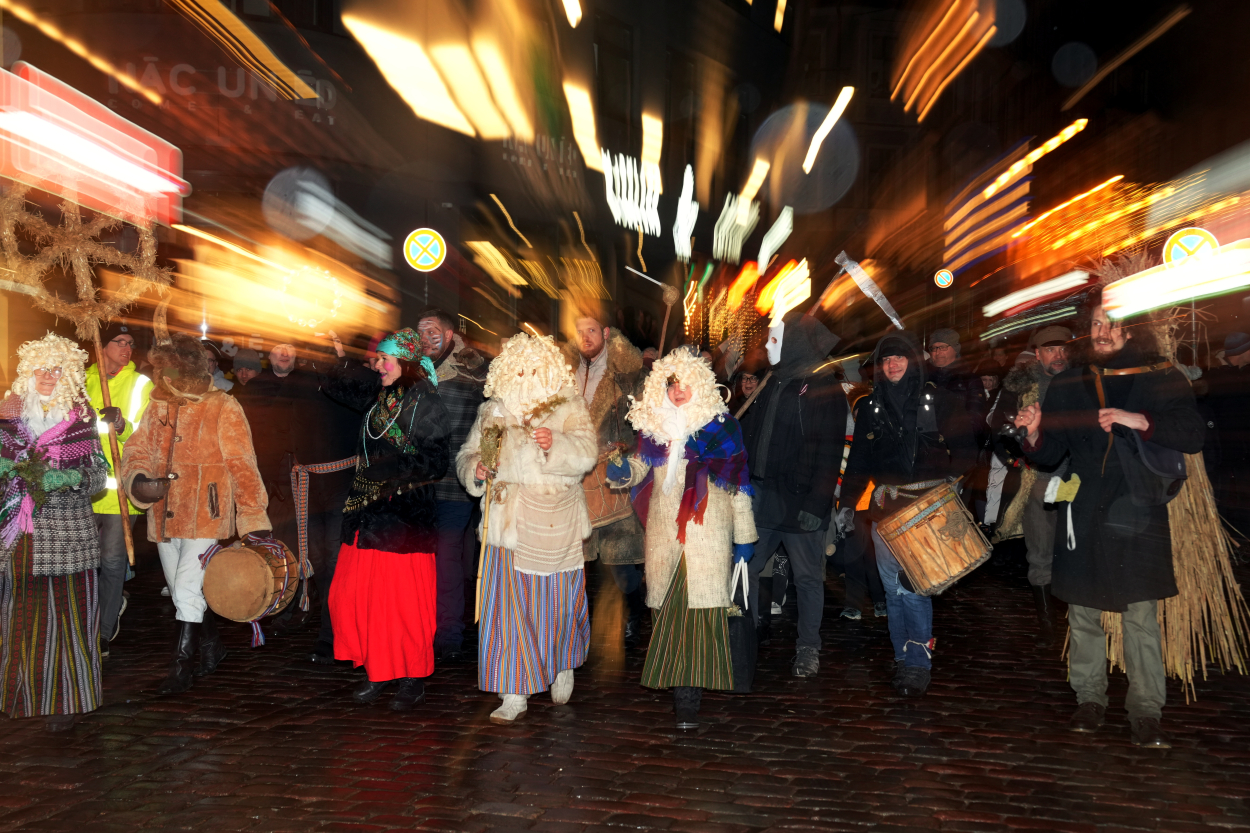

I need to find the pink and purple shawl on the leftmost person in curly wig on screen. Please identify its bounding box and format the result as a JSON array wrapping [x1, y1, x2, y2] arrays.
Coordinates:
[[0, 409, 96, 550]]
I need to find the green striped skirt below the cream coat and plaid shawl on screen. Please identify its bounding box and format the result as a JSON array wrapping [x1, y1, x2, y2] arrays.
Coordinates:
[[643, 555, 734, 689]]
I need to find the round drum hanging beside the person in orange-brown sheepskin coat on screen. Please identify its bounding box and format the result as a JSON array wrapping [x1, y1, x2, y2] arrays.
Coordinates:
[[204, 543, 300, 622]]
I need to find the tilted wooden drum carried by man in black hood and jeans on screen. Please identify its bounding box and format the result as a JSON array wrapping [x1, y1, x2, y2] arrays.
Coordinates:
[[876, 483, 991, 595]]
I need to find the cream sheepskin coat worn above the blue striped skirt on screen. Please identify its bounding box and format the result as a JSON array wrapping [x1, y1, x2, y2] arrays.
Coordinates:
[[456, 385, 599, 574]]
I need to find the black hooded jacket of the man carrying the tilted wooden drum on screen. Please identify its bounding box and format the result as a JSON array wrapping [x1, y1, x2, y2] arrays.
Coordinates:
[[841, 333, 976, 520]]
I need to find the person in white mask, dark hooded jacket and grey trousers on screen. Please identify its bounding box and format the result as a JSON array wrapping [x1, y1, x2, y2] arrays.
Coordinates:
[[743, 310, 846, 677]]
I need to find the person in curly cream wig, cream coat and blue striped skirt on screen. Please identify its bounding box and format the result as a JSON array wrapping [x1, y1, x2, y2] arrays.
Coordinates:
[[456, 333, 599, 723]]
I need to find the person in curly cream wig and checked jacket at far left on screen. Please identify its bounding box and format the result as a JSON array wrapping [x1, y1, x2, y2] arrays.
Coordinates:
[[0, 333, 109, 732]]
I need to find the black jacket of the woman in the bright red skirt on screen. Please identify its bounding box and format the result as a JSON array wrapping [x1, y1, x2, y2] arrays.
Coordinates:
[[328, 359, 451, 553]]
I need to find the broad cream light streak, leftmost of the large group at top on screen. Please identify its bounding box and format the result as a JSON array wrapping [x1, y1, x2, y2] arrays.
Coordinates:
[[345, 14, 478, 136]]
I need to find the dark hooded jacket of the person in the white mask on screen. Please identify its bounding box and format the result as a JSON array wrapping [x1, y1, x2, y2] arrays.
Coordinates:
[[741, 310, 846, 532]]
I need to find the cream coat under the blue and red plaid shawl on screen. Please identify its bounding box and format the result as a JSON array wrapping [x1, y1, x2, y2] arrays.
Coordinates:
[[629, 457, 760, 609]]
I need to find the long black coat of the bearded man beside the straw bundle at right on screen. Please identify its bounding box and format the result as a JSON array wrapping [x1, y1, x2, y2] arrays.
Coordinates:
[[1025, 341, 1205, 612]]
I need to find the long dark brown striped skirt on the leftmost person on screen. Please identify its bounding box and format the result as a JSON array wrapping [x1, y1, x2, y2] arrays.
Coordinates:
[[0, 535, 100, 718]]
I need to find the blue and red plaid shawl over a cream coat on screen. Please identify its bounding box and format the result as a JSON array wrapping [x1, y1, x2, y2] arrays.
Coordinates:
[[630, 414, 755, 544]]
